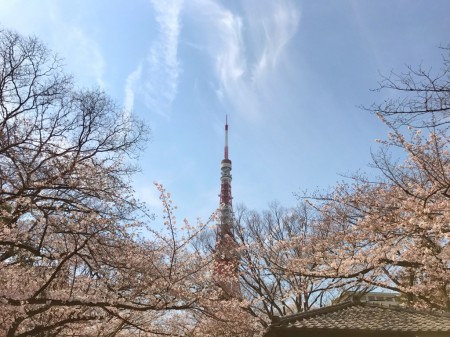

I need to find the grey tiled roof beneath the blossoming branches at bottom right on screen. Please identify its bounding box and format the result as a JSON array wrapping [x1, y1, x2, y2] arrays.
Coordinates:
[[268, 302, 450, 336]]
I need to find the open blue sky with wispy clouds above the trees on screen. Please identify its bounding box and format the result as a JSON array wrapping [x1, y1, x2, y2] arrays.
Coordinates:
[[0, 0, 450, 221]]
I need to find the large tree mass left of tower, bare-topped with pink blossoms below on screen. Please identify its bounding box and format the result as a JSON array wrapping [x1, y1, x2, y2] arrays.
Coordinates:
[[0, 30, 229, 336]]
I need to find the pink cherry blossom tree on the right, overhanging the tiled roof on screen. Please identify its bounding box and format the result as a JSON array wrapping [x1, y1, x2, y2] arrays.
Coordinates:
[[279, 44, 450, 311]]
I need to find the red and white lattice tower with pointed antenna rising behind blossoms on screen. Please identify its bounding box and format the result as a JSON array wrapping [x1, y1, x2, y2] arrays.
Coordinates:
[[214, 118, 241, 298]]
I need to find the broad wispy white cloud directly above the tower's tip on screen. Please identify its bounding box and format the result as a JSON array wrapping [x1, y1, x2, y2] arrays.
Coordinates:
[[185, 0, 300, 119]]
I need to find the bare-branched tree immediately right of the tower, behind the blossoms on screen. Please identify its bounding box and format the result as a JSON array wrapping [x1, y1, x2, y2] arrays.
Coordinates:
[[192, 202, 344, 331]]
